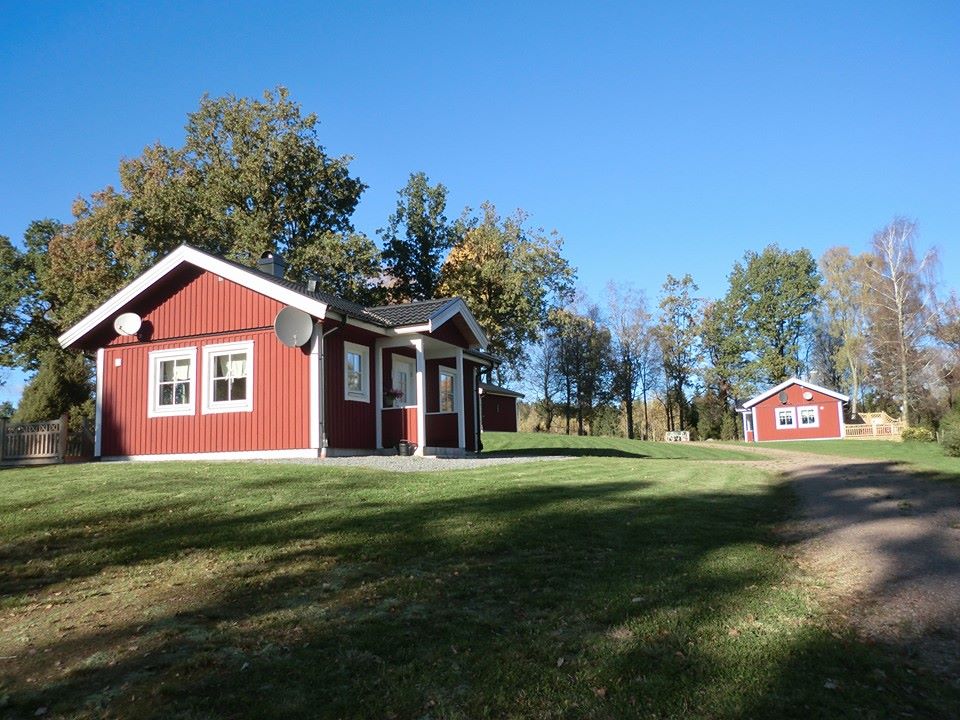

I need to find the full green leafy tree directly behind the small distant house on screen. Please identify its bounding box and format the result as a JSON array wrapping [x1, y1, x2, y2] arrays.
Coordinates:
[[728, 245, 820, 384]]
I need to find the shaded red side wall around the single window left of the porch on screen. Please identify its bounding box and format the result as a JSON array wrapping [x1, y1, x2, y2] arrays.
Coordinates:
[[324, 323, 378, 450]]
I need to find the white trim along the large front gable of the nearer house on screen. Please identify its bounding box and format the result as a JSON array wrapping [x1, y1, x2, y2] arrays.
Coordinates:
[[57, 245, 327, 348]]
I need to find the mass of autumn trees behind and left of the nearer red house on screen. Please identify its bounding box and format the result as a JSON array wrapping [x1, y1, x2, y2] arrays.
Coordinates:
[[0, 87, 574, 422]]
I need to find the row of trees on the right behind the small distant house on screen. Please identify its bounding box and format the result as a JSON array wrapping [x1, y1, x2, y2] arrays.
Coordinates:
[[525, 217, 960, 439]]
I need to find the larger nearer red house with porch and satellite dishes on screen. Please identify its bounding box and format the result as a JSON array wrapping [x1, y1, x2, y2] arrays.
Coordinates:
[[59, 245, 502, 459]]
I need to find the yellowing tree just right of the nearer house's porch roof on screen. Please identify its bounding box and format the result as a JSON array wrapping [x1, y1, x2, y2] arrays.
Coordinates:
[[439, 204, 574, 379]]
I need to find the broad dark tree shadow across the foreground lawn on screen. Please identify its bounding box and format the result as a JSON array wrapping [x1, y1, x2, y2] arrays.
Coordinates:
[[0, 464, 956, 718]]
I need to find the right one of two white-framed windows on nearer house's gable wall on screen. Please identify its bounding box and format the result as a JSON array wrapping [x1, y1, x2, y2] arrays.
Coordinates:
[[202, 340, 253, 414]]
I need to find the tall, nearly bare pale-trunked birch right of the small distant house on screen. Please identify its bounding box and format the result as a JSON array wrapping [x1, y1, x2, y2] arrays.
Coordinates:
[[864, 217, 938, 424]]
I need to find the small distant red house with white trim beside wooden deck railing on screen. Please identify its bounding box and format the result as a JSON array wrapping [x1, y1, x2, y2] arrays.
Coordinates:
[[737, 378, 849, 442]]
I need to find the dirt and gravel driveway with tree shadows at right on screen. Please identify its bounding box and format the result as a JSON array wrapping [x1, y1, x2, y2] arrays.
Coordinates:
[[744, 448, 960, 684]]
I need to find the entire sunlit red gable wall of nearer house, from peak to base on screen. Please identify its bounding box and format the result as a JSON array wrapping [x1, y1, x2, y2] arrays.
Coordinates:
[[100, 268, 310, 457]]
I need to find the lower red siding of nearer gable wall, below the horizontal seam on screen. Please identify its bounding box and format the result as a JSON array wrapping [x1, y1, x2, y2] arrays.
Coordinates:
[[102, 330, 310, 457]]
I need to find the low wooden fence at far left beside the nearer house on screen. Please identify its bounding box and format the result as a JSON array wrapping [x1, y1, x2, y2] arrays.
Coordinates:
[[0, 415, 93, 465]]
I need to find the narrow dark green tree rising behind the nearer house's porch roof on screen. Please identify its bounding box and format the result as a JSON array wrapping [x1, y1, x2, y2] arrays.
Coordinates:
[[377, 172, 460, 302]]
